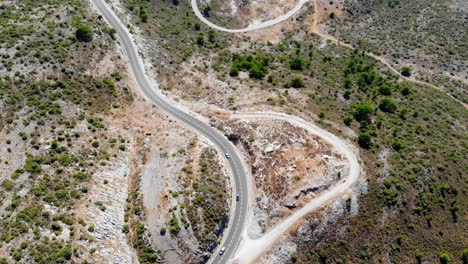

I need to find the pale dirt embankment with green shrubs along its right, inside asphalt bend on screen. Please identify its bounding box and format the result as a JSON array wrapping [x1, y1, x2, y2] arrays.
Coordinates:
[[140, 114, 230, 263]]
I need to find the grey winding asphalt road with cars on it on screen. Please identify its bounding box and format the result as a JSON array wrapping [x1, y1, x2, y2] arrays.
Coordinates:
[[91, 0, 248, 264]]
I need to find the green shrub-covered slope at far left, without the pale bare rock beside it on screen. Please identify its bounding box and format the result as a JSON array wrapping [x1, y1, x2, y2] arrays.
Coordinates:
[[0, 0, 133, 263]]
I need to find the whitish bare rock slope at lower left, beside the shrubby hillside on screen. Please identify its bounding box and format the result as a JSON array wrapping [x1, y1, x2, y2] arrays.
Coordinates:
[[75, 153, 138, 263]]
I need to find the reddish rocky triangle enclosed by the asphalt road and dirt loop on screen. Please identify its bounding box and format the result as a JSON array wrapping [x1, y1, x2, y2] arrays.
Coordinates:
[[211, 116, 347, 232]]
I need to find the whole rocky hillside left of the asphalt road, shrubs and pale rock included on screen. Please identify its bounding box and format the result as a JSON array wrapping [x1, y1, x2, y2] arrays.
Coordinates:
[[0, 0, 151, 263]]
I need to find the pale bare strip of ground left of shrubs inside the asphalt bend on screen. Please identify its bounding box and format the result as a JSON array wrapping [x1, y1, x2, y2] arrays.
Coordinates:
[[141, 116, 201, 263]]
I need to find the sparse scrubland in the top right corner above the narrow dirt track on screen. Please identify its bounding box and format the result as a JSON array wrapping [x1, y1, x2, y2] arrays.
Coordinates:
[[329, 0, 468, 103]]
